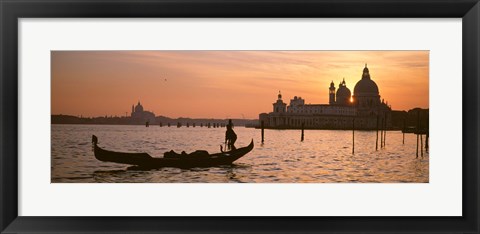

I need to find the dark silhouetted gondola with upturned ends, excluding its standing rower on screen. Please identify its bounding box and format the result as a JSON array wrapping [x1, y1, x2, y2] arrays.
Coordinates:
[[92, 135, 253, 169]]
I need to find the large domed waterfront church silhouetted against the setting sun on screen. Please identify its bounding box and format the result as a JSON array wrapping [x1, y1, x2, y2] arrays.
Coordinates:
[[259, 64, 392, 129]]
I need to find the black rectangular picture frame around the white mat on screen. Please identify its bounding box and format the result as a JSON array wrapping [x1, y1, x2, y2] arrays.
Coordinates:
[[0, 0, 480, 233]]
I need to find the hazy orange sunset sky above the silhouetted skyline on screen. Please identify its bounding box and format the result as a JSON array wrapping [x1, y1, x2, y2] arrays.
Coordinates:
[[51, 51, 429, 119]]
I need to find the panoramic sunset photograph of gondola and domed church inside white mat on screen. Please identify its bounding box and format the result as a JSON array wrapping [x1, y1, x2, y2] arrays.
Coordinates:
[[50, 50, 429, 183]]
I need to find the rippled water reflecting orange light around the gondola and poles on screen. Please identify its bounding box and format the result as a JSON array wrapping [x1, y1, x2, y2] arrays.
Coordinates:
[[51, 125, 429, 183]]
